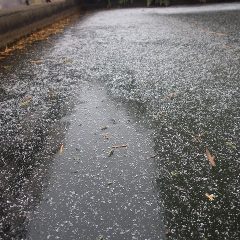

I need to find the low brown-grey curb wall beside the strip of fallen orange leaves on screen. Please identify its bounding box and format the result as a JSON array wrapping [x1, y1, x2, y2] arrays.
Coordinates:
[[0, 1, 80, 49]]
